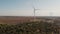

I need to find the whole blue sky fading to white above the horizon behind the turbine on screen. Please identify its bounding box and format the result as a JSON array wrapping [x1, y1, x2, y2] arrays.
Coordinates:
[[0, 0, 60, 16]]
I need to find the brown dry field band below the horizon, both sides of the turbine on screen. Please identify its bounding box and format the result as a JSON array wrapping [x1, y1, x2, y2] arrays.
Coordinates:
[[0, 16, 60, 24]]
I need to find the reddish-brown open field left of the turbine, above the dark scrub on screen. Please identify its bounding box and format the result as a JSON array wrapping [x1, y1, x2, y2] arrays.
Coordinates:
[[0, 16, 33, 24]]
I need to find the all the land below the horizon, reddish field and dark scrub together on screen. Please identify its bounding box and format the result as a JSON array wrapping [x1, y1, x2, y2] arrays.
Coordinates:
[[0, 16, 60, 34]]
